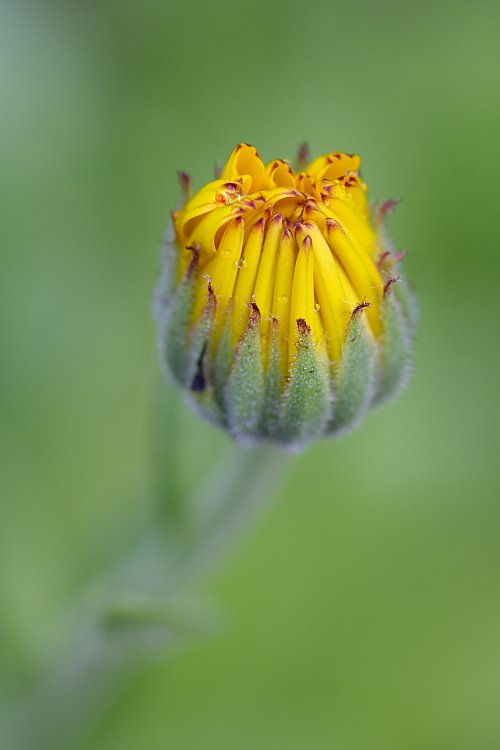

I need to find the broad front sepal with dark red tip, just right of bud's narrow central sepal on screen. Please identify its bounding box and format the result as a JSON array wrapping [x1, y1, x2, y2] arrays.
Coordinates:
[[278, 319, 332, 448]]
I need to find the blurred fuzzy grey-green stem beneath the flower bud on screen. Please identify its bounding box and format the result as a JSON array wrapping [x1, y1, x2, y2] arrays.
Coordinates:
[[0, 446, 286, 750]]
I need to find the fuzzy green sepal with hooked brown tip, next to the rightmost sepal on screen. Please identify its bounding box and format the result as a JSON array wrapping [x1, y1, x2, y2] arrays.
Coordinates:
[[327, 304, 376, 435]]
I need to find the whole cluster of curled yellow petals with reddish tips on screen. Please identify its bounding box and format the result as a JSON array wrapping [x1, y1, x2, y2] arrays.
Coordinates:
[[174, 143, 396, 363]]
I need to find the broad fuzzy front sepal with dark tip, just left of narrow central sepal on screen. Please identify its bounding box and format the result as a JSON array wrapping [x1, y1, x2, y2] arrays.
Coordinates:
[[225, 305, 265, 443]]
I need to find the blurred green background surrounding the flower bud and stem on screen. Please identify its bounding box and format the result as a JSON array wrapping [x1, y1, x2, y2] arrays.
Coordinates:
[[0, 0, 500, 750]]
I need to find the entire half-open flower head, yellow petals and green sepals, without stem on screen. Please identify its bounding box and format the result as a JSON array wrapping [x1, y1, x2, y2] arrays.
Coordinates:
[[158, 144, 415, 447]]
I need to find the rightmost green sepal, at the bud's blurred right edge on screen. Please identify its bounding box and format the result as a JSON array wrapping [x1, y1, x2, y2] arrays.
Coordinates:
[[373, 290, 411, 405]]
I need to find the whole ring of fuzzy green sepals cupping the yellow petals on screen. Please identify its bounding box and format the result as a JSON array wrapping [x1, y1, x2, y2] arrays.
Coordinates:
[[157, 251, 417, 450]]
